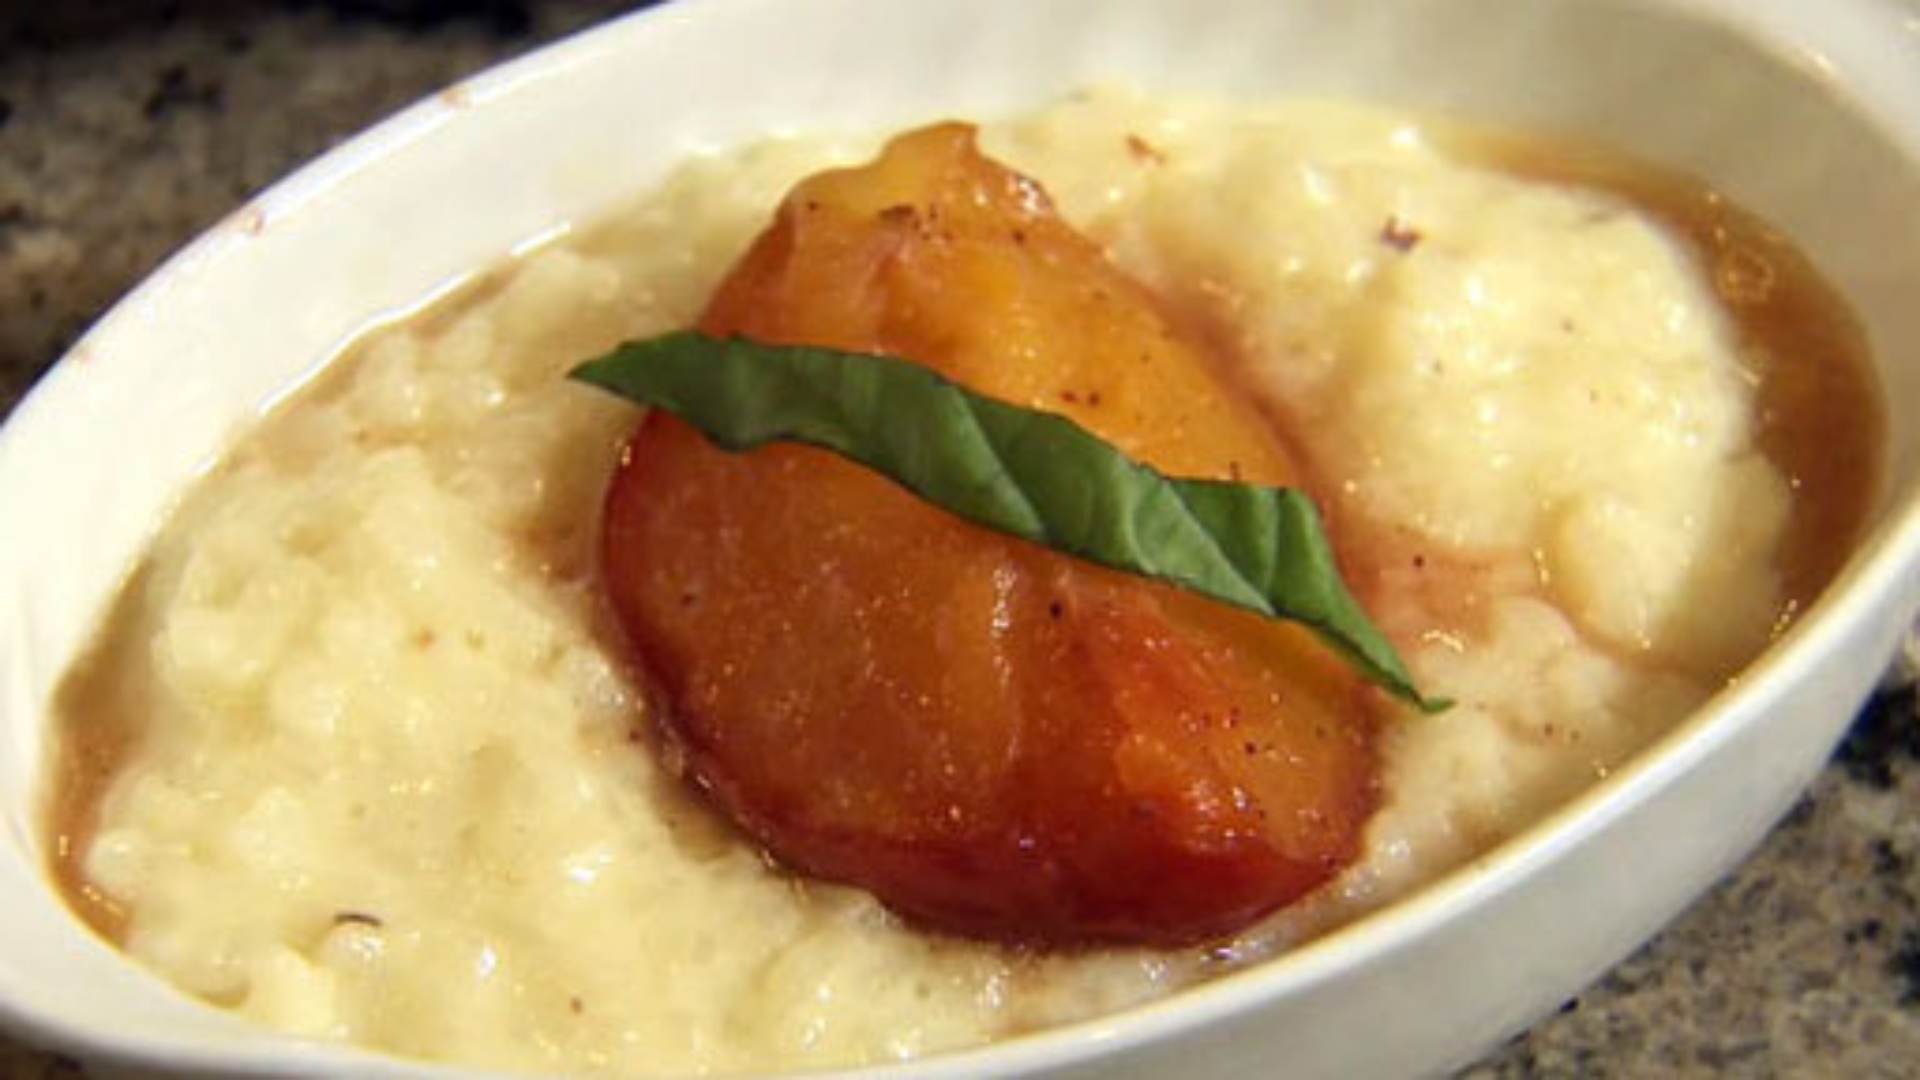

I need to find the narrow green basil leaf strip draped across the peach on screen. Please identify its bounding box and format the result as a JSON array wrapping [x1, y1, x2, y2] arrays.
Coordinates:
[[572, 331, 1450, 713]]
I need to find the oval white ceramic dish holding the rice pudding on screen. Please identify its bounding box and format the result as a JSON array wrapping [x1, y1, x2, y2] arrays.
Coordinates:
[[0, 0, 1920, 1078]]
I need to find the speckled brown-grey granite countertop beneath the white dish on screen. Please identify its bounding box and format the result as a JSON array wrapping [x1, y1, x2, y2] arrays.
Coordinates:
[[0, 0, 1920, 1080]]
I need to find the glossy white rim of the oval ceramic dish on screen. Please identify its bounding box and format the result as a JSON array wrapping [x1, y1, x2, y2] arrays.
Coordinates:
[[0, 0, 1920, 1080]]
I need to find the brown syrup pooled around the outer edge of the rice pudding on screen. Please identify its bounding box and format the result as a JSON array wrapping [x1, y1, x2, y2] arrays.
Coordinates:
[[42, 127, 1885, 942]]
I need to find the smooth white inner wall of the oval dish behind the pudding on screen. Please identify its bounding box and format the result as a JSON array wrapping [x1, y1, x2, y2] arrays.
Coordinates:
[[0, 0, 1920, 1074]]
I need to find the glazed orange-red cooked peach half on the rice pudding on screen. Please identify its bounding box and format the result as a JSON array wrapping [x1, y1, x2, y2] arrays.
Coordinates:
[[605, 125, 1377, 944]]
